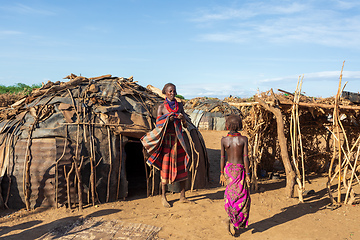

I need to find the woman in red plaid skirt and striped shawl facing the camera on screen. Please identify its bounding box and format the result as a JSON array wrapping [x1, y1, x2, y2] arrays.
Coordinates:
[[141, 83, 189, 207]]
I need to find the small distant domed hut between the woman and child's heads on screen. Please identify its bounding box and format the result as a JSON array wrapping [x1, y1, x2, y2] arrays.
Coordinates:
[[184, 97, 241, 131]]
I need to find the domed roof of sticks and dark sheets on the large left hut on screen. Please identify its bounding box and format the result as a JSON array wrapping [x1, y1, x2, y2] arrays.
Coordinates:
[[0, 74, 163, 138]]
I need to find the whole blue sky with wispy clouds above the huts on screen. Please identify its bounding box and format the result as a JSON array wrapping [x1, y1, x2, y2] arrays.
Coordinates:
[[0, 0, 360, 98]]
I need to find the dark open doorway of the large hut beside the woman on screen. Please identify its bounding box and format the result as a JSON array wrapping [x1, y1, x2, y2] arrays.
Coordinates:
[[125, 138, 149, 197]]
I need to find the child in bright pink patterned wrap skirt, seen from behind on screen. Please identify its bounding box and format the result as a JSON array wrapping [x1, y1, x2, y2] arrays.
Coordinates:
[[220, 114, 251, 235]]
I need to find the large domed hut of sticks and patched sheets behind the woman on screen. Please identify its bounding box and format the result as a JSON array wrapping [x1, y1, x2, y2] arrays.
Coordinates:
[[0, 74, 209, 209]]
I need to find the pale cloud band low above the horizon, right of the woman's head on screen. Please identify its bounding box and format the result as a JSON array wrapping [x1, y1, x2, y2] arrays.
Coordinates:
[[177, 71, 360, 99]]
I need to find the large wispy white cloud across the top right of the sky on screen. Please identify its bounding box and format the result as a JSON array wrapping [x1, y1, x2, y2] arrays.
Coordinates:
[[193, 1, 360, 48]]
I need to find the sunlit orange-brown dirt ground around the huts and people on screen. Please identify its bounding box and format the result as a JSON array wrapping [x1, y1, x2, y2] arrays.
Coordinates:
[[0, 131, 360, 240]]
